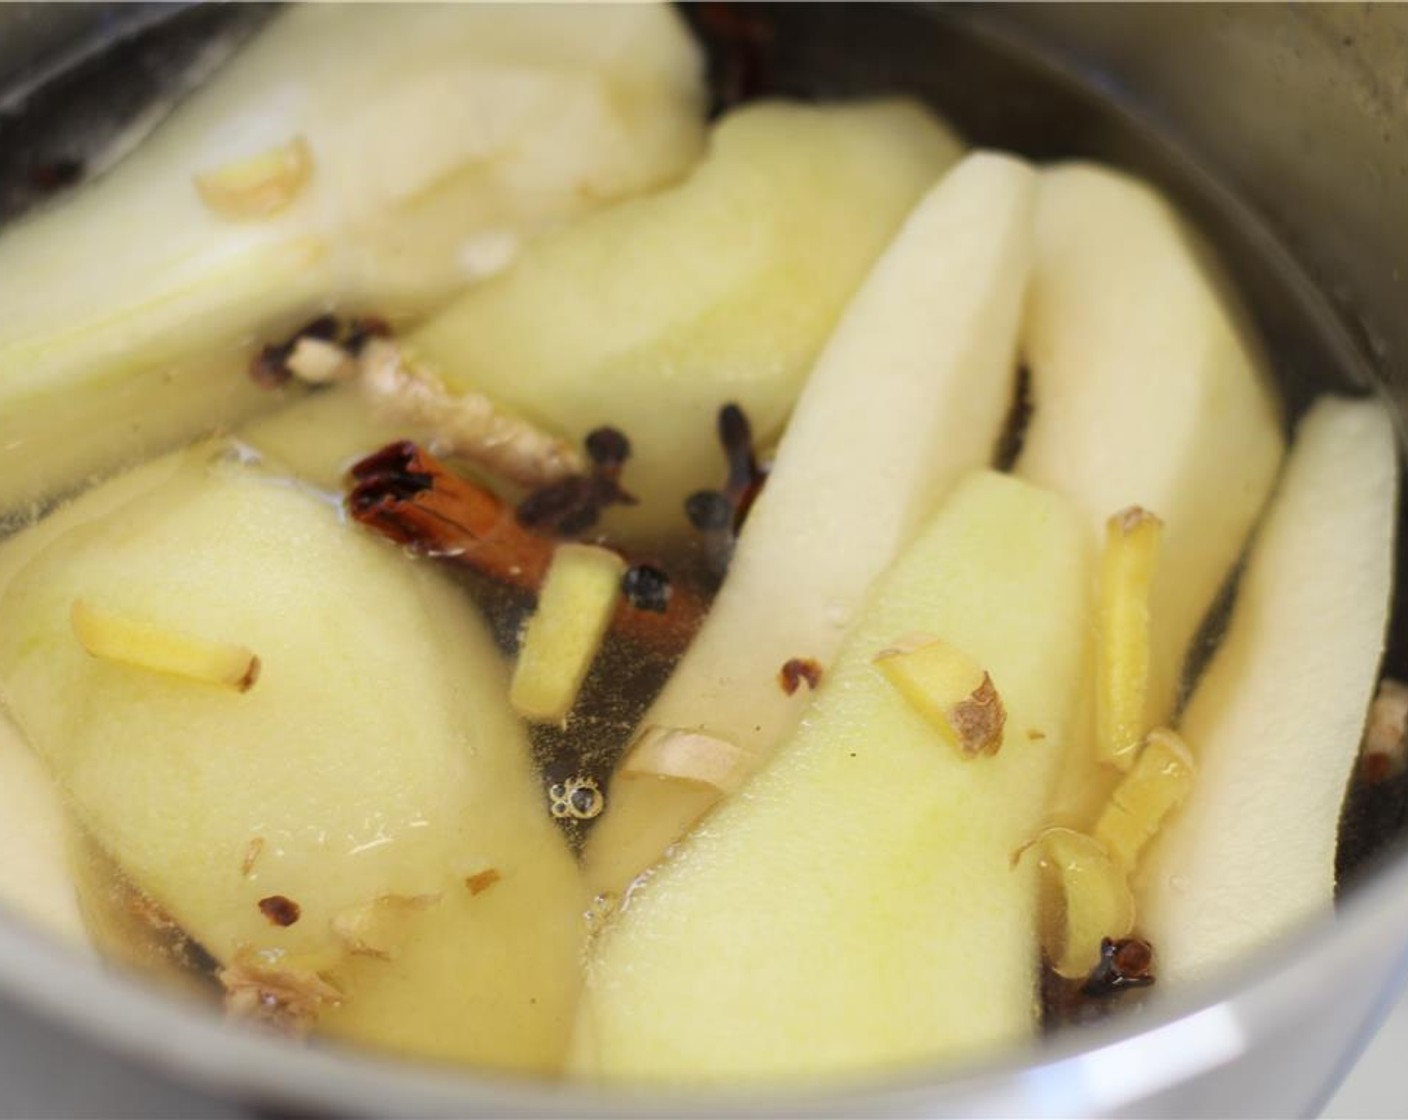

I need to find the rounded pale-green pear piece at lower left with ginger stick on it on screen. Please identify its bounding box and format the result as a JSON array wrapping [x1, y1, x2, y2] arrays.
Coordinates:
[[0, 448, 583, 1072]]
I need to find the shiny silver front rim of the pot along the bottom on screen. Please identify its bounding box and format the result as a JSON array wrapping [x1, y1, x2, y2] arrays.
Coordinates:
[[0, 6, 1408, 1117]]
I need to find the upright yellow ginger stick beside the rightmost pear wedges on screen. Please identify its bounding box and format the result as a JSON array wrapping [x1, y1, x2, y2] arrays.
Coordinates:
[[1095, 506, 1163, 769]]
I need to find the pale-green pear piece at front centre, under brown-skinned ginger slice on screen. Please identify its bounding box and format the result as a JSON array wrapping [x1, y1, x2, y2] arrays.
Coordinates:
[[573, 472, 1093, 1085]]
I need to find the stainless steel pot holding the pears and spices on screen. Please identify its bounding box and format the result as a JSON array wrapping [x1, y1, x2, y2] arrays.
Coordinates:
[[0, 4, 1408, 1116]]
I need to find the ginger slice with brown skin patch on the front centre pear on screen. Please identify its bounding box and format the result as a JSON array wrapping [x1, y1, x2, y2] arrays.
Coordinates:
[[876, 635, 1007, 758]]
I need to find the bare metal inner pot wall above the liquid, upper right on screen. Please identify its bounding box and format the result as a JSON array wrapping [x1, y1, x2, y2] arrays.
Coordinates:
[[977, 4, 1408, 411]]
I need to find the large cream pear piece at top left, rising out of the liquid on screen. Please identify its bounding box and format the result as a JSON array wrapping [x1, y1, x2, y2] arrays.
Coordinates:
[[0, 4, 703, 507]]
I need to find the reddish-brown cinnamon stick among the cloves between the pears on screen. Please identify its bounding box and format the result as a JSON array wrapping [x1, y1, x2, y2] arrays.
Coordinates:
[[346, 440, 705, 651]]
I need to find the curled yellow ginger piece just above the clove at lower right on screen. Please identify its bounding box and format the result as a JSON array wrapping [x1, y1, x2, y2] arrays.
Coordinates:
[[1018, 828, 1135, 979]]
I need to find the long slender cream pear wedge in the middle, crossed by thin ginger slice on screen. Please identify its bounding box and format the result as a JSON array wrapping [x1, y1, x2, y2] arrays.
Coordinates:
[[586, 152, 1035, 892]]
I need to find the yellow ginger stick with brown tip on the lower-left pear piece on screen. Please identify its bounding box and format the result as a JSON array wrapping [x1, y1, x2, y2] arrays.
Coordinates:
[[69, 599, 259, 692]]
